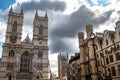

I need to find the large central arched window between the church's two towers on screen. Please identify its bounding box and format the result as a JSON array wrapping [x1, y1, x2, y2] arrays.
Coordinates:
[[20, 52, 30, 72]]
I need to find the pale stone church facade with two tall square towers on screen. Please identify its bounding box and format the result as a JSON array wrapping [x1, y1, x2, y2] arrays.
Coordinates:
[[0, 7, 50, 80]]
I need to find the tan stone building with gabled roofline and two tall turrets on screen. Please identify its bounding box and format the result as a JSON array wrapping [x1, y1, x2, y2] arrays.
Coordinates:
[[78, 21, 120, 80]]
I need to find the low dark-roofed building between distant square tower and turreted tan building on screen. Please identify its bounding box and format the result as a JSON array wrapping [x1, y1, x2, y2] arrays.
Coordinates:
[[67, 53, 81, 80]]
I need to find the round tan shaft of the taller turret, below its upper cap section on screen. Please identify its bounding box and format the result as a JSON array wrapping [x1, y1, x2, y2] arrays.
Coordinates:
[[88, 38, 98, 80]]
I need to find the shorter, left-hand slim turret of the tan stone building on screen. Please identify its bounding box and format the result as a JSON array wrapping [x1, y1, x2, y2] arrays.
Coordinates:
[[78, 32, 86, 80]]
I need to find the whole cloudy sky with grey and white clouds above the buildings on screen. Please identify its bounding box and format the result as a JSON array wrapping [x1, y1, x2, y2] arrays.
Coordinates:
[[0, 0, 120, 73]]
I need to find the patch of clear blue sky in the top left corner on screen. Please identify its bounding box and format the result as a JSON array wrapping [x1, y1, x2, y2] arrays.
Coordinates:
[[0, 0, 15, 10]]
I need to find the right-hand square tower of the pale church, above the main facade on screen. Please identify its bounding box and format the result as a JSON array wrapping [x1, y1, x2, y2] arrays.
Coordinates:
[[33, 10, 48, 45]]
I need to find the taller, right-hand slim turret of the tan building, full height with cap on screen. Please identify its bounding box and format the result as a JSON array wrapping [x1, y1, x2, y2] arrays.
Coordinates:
[[86, 25, 98, 80]]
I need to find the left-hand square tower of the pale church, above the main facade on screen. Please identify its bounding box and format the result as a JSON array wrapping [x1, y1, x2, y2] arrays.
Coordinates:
[[5, 7, 24, 44]]
